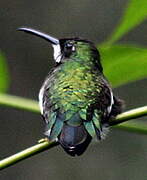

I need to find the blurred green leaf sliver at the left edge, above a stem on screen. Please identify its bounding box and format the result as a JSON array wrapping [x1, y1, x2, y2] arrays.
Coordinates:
[[0, 53, 10, 92]]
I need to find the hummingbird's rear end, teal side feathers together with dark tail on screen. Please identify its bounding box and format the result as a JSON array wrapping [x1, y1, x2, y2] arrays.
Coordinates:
[[45, 110, 110, 156]]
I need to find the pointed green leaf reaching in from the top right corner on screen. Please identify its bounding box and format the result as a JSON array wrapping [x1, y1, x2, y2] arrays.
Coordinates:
[[106, 0, 147, 45]]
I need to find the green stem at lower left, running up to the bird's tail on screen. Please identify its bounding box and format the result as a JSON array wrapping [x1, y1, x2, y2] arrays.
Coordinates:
[[0, 141, 58, 170]]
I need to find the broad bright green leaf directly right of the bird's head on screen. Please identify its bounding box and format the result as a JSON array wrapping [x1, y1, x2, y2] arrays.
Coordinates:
[[100, 45, 147, 87]]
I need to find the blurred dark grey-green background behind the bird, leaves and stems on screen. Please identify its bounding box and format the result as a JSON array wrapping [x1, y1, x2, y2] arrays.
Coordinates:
[[0, 0, 147, 180]]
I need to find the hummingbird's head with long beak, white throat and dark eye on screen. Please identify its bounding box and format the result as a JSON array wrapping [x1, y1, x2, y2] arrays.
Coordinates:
[[18, 27, 102, 71]]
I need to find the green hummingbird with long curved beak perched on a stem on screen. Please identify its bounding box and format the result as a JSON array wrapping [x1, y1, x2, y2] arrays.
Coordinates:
[[18, 27, 122, 156]]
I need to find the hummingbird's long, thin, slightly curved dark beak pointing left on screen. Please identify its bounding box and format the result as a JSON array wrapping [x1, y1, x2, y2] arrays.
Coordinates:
[[18, 27, 59, 45]]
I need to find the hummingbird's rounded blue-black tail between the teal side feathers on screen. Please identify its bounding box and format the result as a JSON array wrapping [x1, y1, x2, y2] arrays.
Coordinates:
[[59, 124, 92, 156]]
